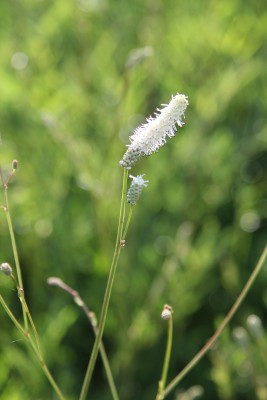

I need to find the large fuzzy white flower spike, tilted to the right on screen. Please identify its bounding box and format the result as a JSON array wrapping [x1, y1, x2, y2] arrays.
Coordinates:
[[120, 93, 188, 169]]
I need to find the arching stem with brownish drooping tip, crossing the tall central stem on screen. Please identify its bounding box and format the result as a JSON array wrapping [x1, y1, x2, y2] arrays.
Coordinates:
[[48, 277, 119, 400]]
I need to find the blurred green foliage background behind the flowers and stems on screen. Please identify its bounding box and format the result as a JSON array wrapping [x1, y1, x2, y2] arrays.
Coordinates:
[[0, 0, 267, 400]]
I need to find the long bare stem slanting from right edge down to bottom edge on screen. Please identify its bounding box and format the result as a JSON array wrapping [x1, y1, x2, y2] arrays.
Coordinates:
[[163, 245, 267, 398]]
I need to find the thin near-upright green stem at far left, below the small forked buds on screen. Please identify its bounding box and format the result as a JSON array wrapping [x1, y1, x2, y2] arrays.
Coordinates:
[[4, 185, 29, 331]]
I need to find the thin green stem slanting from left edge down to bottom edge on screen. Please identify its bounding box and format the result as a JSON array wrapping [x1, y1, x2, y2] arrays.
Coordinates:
[[0, 295, 65, 400]]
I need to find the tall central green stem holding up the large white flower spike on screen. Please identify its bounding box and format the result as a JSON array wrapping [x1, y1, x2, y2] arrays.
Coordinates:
[[79, 168, 128, 400]]
